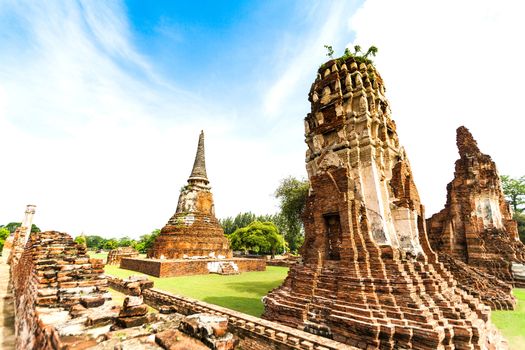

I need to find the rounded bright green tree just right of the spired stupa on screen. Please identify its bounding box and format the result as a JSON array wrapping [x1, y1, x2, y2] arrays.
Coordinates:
[[229, 221, 285, 258]]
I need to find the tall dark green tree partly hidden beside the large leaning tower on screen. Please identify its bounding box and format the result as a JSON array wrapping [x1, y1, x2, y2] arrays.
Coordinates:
[[275, 176, 310, 252]]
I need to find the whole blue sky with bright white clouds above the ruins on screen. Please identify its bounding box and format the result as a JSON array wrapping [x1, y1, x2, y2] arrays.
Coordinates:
[[0, 0, 525, 237]]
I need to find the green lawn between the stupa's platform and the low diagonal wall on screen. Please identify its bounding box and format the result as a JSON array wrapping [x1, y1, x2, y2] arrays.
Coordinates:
[[101, 265, 288, 317]]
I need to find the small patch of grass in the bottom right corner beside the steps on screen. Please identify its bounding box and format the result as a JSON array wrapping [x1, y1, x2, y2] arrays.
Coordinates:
[[492, 288, 525, 350]]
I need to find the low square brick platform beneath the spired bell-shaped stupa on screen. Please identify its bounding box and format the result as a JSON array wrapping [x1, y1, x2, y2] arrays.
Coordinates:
[[120, 258, 266, 277]]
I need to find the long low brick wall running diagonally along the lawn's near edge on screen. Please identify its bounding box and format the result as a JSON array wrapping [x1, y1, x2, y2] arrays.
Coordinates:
[[143, 288, 357, 350]]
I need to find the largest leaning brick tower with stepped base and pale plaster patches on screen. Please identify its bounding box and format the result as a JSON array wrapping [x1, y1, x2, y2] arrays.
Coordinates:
[[263, 58, 506, 349]]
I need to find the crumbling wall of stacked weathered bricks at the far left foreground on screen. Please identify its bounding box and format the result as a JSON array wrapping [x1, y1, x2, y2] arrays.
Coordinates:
[[11, 231, 106, 349]]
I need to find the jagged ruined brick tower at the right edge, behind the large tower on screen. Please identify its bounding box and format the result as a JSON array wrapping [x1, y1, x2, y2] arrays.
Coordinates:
[[427, 126, 525, 290]]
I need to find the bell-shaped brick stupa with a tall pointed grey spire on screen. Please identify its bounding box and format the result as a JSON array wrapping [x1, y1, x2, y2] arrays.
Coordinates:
[[148, 132, 232, 259]]
